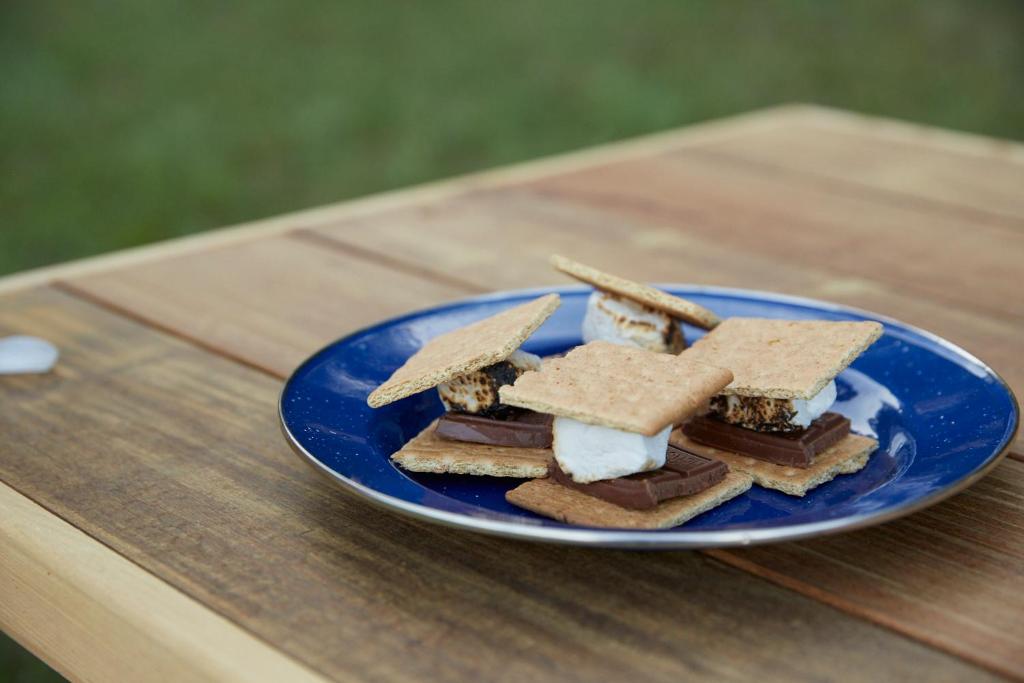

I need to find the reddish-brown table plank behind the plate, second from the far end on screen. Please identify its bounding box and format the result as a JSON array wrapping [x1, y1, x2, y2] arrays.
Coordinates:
[[531, 151, 1024, 319]]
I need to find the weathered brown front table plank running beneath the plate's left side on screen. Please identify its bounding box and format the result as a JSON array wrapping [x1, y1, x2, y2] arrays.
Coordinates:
[[0, 291, 986, 681]]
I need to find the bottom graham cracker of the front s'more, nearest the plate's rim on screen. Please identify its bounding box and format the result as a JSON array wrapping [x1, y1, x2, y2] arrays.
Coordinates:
[[505, 472, 752, 528]]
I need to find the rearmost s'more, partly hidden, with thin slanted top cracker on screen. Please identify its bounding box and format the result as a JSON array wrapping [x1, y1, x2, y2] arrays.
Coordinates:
[[551, 254, 720, 353]]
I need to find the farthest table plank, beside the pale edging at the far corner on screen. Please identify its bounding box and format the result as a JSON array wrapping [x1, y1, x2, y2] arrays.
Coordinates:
[[684, 110, 1024, 228]]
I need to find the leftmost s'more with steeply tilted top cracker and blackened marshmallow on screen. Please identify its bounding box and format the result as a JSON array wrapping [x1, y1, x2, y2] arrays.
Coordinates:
[[367, 294, 559, 477]]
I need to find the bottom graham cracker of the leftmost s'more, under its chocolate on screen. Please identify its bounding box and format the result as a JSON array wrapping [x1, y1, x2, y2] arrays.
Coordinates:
[[391, 420, 553, 478]]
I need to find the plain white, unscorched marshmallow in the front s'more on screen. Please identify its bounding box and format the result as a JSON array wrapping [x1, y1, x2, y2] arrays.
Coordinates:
[[552, 417, 672, 483]]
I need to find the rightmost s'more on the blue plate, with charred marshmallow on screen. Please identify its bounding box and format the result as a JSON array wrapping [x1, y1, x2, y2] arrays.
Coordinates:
[[671, 317, 882, 496]]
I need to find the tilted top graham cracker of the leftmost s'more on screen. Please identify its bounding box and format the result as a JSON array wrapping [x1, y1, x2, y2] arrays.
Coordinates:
[[367, 294, 560, 408]]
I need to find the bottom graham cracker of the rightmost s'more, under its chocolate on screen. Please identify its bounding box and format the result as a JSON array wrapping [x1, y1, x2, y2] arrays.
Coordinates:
[[669, 429, 879, 496]]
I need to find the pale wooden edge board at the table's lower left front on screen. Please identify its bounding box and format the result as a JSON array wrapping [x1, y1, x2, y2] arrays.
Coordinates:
[[0, 481, 326, 683]]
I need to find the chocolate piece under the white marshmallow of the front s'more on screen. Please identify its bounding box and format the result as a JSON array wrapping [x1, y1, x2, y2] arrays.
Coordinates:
[[550, 445, 729, 510]]
